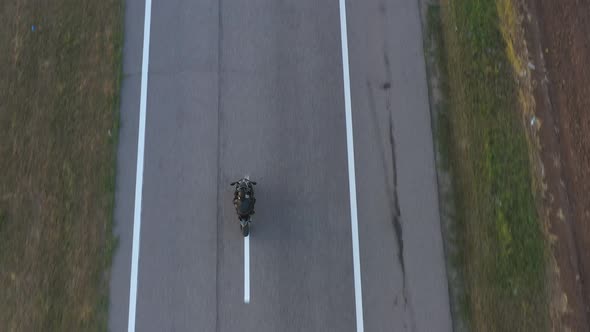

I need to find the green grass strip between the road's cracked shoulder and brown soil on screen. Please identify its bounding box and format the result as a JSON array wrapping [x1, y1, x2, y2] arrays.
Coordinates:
[[428, 0, 548, 331]]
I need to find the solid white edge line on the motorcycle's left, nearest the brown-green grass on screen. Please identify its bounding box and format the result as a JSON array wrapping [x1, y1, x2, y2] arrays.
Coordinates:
[[127, 0, 152, 332]]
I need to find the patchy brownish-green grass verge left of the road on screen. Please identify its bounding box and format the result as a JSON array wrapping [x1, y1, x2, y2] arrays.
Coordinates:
[[0, 0, 123, 331]]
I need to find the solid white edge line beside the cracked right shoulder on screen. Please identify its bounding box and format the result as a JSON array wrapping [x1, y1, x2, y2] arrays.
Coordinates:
[[339, 0, 364, 332]]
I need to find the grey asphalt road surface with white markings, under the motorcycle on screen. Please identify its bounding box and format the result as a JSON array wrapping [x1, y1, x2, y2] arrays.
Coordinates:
[[109, 0, 451, 331]]
